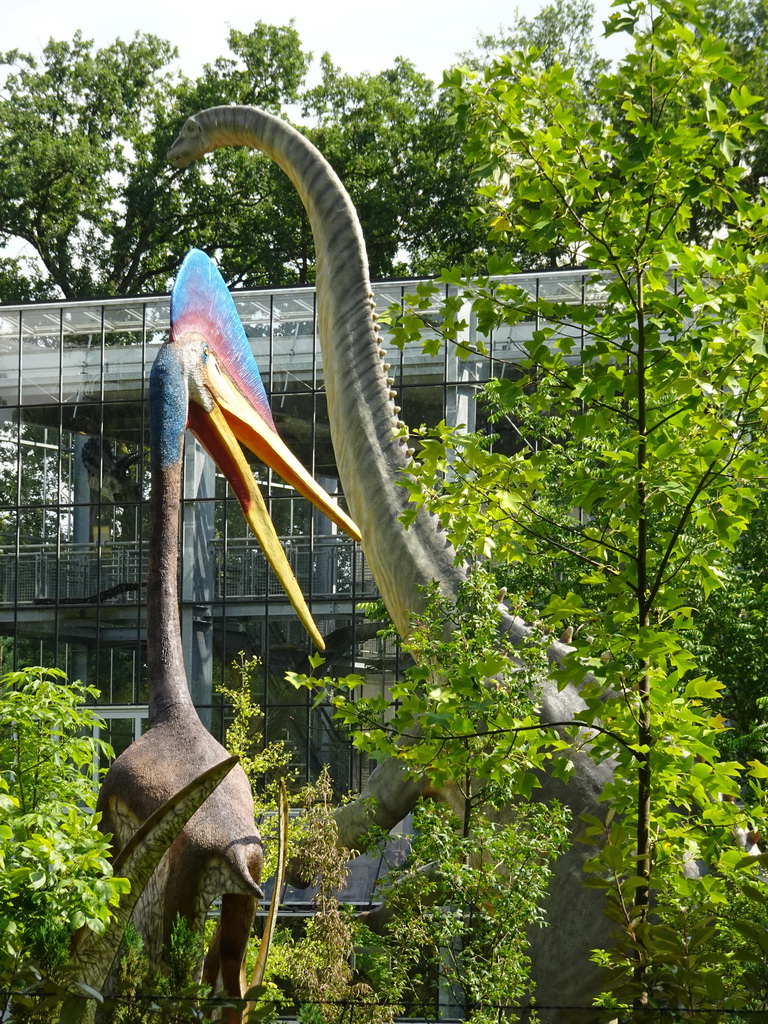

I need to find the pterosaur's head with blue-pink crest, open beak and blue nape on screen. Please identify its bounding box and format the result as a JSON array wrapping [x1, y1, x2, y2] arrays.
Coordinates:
[[155, 249, 359, 648]]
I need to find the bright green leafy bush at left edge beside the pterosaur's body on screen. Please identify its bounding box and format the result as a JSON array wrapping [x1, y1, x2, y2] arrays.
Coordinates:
[[0, 668, 128, 1011]]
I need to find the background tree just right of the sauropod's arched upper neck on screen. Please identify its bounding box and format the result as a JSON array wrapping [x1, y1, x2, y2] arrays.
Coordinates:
[[302, 54, 483, 278]]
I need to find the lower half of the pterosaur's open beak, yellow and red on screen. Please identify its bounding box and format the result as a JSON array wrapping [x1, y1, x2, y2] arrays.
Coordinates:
[[187, 401, 326, 650]]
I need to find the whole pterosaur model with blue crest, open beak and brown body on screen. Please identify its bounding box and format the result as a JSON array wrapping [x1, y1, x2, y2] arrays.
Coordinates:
[[98, 250, 358, 1022]]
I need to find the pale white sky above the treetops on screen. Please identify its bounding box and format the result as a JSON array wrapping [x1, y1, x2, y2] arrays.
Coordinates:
[[0, 0, 626, 82]]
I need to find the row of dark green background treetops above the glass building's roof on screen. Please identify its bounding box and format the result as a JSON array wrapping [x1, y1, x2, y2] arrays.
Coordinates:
[[0, 23, 479, 301]]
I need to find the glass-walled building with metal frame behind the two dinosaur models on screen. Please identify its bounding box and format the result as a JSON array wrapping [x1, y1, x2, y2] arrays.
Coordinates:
[[0, 271, 602, 791]]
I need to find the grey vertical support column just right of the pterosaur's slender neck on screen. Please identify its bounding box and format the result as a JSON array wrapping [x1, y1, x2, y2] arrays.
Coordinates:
[[180, 434, 216, 728]]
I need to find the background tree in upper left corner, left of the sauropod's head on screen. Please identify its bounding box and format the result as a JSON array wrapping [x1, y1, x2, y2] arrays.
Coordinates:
[[0, 33, 175, 298]]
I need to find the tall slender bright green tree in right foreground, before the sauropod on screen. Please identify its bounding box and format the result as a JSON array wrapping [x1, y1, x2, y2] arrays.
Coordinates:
[[376, 0, 768, 1010]]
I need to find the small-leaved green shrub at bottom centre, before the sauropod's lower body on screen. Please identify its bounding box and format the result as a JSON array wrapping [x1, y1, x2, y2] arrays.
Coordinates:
[[374, 802, 566, 1024]]
